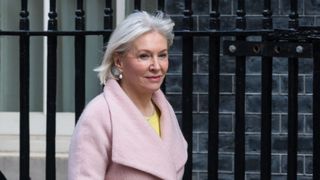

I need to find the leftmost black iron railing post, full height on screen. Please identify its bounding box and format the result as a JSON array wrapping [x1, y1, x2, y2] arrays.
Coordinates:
[[19, 0, 30, 180]]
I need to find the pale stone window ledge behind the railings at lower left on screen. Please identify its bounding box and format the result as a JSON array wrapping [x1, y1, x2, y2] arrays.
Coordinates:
[[0, 112, 74, 180]]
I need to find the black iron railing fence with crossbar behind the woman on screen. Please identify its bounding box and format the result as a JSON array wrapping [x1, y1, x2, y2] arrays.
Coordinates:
[[0, 0, 320, 180]]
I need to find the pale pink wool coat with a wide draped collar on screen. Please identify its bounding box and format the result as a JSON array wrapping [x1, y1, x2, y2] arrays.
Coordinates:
[[68, 80, 187, 180]]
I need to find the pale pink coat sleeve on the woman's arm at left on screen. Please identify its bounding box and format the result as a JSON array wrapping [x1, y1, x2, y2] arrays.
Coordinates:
[[68, 97, 111, 180]]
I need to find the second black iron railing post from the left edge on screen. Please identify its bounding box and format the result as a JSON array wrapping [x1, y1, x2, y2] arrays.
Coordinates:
[[46, 0, 57, 180]]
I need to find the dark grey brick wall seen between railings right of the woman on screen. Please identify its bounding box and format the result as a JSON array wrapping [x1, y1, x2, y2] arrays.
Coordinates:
[[166, 0, 320, 180]]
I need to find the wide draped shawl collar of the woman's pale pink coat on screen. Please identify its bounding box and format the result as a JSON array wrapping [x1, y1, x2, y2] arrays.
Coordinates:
[[104, 80, 187, 179]]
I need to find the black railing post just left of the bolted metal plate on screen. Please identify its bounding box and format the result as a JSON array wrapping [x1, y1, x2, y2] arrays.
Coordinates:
[[208, 0, 220, 179]]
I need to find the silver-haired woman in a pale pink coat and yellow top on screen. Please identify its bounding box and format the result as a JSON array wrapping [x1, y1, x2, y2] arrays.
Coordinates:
[[69, 12, 187, 180]]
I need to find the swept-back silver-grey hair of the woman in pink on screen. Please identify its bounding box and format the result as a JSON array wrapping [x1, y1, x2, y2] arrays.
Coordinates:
[[95, 11, 174, 84]]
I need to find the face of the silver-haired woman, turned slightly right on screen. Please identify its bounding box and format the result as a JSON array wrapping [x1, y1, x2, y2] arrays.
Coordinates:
[[115, 31, 168, 95]]
